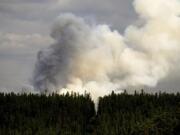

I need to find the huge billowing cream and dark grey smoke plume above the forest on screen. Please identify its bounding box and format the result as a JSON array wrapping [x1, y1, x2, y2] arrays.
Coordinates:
[[33, 0, 180, 100]]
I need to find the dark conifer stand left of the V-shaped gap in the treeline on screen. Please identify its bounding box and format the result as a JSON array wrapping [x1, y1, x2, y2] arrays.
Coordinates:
[[0, 93, 95, 135]]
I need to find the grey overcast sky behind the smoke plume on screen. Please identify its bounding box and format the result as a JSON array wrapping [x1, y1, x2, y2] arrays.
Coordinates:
[[0, 0, 180, 92]]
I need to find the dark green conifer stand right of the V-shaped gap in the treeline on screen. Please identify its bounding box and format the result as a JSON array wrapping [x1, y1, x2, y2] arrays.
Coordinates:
[[95, 91, 180, 135]]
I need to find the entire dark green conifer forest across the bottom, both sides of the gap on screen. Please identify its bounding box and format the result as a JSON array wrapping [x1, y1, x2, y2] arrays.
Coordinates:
[[0, 91, 180, 135]]
